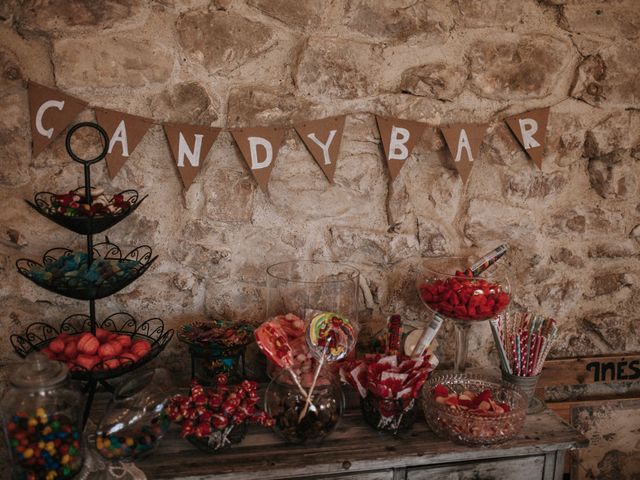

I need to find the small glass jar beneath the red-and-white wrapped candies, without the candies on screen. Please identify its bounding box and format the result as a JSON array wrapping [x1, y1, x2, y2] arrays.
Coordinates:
[[360, 392, 416, 435]]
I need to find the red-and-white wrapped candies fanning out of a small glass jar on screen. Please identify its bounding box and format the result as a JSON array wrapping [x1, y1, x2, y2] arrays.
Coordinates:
[[340, 354, 437, 433]]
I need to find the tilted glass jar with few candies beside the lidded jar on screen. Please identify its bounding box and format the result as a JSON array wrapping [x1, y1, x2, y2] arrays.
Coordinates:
[[95, 368, 173, 461]]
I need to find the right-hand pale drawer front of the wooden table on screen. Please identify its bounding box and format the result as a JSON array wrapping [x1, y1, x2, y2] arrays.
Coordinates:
[[407, 455, 544, 480]]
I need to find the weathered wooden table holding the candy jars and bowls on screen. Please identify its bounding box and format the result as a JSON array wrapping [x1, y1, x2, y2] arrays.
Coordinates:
[[136, 407, 587, 480]]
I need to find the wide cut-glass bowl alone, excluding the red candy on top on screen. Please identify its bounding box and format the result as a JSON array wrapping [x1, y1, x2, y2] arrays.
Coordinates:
[[422, 374, 528, 445]]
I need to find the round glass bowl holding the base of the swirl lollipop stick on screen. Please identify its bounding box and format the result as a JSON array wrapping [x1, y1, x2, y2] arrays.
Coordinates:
[[265, 368, 344, 444]]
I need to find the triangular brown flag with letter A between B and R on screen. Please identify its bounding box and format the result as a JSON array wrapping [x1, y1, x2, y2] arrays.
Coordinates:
[[440, 123, 489, 183]]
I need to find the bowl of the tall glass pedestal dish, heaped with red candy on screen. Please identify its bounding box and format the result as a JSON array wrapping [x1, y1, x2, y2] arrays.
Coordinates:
[[417, 260, 511, 321]]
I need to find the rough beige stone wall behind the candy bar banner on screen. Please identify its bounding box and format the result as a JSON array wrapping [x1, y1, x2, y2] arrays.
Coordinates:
[[0, 0, 640, 472]]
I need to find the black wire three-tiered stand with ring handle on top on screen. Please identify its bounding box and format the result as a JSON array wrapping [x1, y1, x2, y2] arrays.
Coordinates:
[[11, 122, 173, 424]]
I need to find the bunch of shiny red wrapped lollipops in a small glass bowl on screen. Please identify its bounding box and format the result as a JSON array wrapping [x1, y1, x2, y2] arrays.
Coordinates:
[[167, 375, 274, 450]]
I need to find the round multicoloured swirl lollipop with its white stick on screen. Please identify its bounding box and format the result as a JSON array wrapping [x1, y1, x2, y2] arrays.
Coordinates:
[[298, 312, 356, 421]]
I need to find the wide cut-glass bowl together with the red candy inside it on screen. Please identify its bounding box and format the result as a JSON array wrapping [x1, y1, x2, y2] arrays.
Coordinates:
[[422, 374, 528, 445]]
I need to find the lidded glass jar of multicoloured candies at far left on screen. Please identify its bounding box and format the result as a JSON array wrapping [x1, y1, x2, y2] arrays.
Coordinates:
[[0, 352, 84, 480]]
